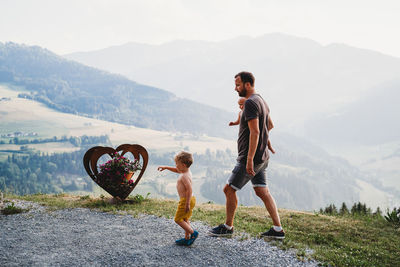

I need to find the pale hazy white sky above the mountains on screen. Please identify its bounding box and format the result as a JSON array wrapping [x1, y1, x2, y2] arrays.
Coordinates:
[[0, 0, 400, 57]]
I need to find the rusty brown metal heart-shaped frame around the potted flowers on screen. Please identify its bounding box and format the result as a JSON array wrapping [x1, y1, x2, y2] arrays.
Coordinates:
[[83, 144, 149, 200]]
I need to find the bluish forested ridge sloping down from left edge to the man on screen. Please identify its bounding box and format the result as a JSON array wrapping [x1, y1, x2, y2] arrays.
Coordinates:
[[0, 43, 235, 137]]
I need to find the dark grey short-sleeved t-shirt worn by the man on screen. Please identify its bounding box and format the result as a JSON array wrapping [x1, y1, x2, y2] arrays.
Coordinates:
[[237, 94, 269, 164]]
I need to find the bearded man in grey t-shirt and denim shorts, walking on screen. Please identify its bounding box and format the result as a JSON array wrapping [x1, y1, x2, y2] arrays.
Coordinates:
[[209, 71, 285, 239]]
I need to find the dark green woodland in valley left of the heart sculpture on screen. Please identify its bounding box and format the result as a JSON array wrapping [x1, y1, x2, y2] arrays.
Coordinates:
[[0, 135, 111, 195]]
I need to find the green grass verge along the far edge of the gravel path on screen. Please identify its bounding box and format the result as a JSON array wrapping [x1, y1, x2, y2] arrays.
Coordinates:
[[3, 194, 400, 266]]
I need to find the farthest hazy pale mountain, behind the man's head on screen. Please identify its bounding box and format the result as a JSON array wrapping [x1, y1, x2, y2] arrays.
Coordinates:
[[65, 33, 400, 127]]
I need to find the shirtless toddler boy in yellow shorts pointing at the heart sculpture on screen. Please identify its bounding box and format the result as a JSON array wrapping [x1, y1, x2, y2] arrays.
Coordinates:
[[158, 151, 199, 246]]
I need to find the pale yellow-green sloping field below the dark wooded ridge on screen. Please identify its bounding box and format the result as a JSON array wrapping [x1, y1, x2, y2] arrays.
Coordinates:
[[0, 84, 236, 153]]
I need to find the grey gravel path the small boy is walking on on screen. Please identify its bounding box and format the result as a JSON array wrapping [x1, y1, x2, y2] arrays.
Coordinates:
[[0, 201, 318, 267]]
